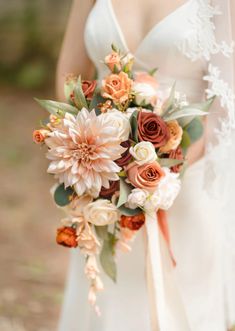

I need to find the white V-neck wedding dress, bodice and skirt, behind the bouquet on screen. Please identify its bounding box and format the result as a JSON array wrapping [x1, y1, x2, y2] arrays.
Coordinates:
[[59, 0, 235, 331]]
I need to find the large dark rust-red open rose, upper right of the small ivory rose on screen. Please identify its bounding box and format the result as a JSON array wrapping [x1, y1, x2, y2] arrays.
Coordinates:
[[138, 111, 170, 148]]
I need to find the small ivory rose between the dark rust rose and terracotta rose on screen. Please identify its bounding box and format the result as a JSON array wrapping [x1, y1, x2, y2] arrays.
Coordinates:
[[130, 141, 157, 165]]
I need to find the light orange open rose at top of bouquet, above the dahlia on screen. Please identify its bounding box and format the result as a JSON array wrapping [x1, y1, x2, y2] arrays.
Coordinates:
[[102, 71, 133, 104]]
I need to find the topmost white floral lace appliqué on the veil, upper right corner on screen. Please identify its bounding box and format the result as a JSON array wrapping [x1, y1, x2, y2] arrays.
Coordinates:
[[178, 0, 234, 61]]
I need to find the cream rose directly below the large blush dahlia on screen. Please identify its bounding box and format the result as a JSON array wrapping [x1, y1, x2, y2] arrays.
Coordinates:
[[83, 199, 120, 226]]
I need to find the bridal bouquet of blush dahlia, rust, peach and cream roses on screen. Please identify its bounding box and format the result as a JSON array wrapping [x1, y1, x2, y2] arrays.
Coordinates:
[[33, 46, 213, 311]]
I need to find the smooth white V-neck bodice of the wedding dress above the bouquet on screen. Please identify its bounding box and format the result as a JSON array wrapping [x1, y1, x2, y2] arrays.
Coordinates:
[[85, 0, 209, 84]]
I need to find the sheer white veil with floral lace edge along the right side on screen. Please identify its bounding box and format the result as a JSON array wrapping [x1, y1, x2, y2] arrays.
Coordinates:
[[181, 0, 235, 324]]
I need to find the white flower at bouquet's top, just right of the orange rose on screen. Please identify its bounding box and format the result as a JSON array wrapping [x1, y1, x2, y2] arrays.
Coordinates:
[[133, 83, 157, 105]]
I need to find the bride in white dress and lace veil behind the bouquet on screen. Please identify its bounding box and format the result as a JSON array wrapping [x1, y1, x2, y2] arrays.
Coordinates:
[[57, 0, 235, 331]]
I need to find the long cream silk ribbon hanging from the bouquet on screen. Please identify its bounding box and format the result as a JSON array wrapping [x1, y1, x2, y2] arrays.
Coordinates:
[[145, 212, 190, 331]]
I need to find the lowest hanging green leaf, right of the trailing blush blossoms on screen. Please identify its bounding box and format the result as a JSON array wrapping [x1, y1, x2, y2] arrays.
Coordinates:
[[100, 233, 117, 282]]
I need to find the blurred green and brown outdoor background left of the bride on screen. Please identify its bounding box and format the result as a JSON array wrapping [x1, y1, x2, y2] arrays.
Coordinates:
[[0, 0, 71, 331]]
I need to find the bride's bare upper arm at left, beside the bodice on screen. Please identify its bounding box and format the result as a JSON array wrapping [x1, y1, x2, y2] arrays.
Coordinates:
[[56, 0, 95, 100]]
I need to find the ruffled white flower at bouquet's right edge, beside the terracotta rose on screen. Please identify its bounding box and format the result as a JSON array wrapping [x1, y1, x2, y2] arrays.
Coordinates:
[[154, 168, 181, 210]]
